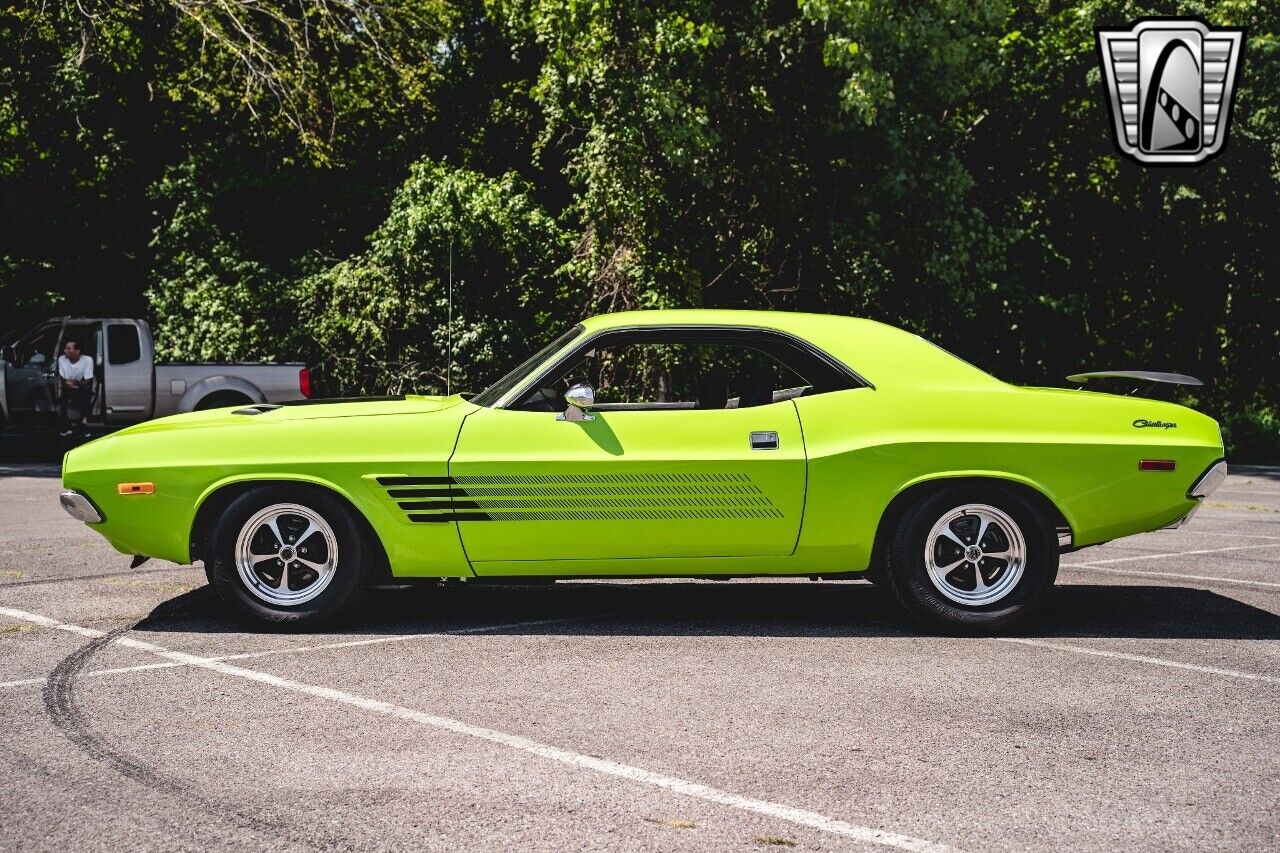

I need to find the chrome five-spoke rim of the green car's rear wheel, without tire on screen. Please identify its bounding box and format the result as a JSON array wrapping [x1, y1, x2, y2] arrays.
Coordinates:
[[924, 503, 1027, 607]]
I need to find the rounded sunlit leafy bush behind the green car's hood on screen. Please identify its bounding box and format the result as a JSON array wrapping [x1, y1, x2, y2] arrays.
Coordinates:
[[294, 160, 573, 393]]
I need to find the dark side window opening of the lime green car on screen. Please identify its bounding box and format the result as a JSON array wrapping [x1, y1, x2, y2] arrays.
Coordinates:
[[516, 329, 856, 411]]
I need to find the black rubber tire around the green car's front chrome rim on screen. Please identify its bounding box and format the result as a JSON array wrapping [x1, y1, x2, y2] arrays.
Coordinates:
[[205, 484, 381, 629]]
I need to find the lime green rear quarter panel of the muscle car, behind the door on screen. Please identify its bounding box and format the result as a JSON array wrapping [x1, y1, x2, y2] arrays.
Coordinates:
[[796, 383, 1222, 570]]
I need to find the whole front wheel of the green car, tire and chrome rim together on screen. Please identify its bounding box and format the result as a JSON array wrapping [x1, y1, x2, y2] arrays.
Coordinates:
[[206, 485, 380, 629]]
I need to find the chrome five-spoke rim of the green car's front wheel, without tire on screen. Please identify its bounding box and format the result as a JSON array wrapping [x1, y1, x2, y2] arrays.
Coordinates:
[[236, 503, 338, 607]]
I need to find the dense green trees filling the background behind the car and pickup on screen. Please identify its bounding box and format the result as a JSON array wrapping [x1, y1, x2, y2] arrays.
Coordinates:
[[0, 0, 1280, 450]]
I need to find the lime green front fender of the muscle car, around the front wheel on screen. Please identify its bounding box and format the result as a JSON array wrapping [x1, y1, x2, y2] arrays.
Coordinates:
[[63, 403, 471, 576]]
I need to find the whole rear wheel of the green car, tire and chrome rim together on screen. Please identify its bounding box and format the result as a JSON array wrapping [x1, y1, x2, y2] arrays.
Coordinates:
[[882, 485, 1059, 633]]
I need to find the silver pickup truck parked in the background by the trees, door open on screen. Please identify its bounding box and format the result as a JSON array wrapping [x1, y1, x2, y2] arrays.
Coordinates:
[[0, 316, 311, 427]]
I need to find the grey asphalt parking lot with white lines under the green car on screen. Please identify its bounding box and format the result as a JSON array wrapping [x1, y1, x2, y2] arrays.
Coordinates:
[[0, 464, 1280, 852]]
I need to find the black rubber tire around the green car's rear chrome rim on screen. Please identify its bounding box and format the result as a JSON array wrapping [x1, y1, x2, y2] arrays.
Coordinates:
[[877, 483, 1059, 634]]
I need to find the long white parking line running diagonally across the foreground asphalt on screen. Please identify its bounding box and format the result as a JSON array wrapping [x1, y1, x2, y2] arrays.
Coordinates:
[[0, 607, 955, 853]]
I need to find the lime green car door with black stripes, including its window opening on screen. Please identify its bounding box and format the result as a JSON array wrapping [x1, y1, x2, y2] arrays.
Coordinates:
[[450, 330, 805, 574]]
